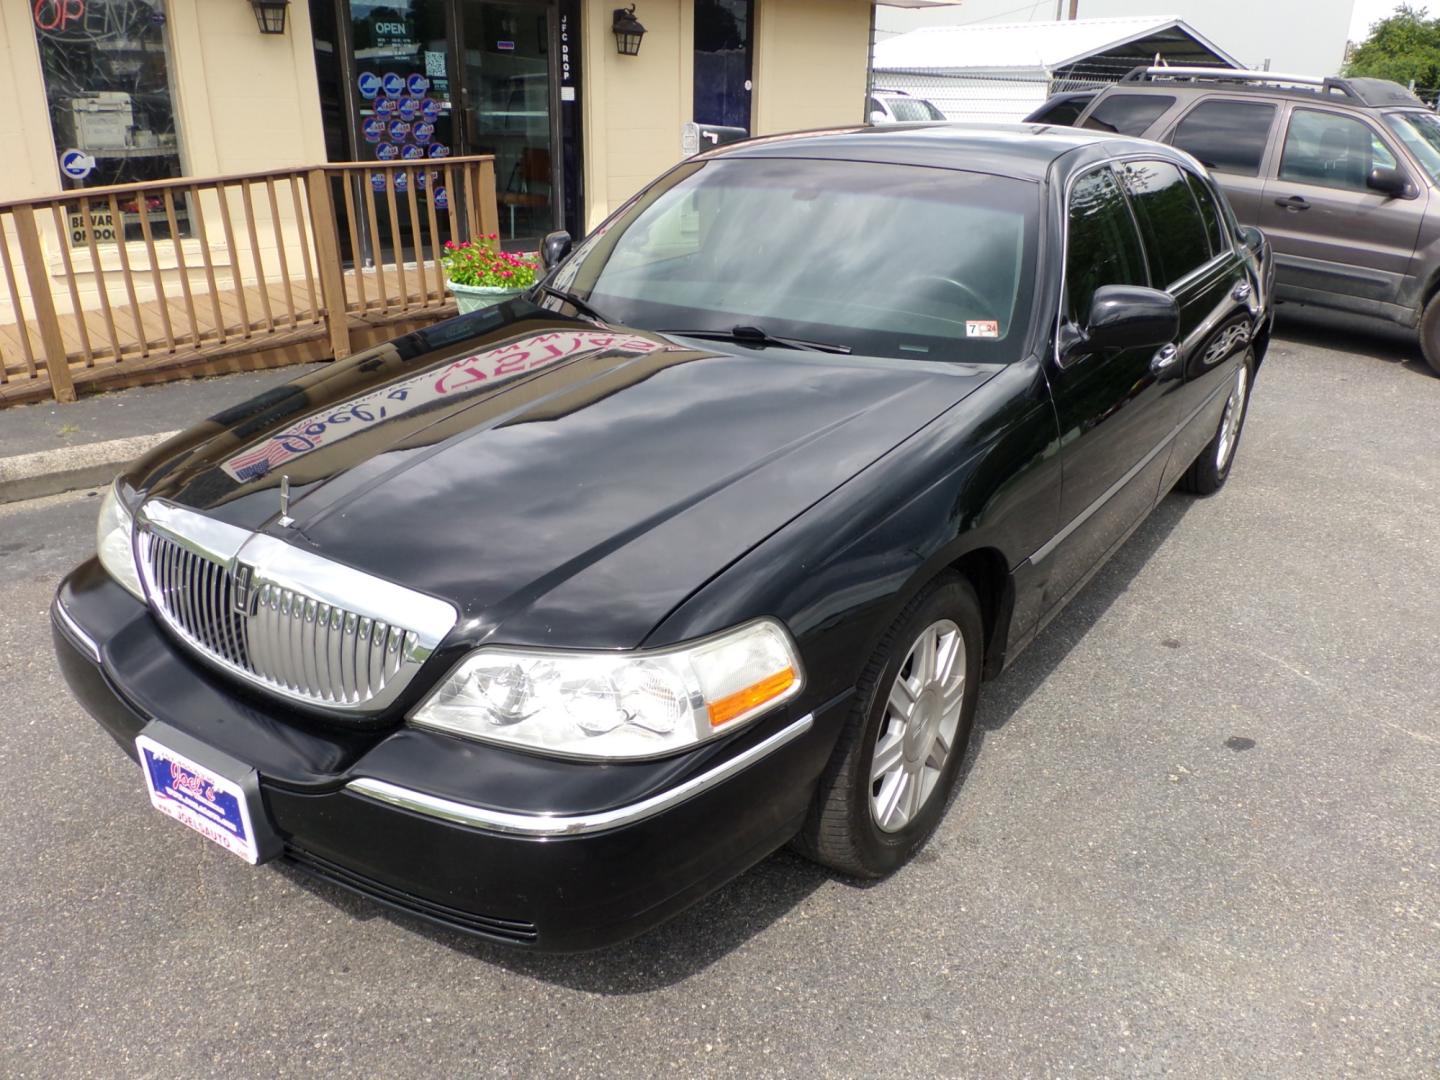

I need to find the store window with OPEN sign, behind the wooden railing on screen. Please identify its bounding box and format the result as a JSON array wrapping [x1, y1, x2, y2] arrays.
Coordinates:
[[30, 0, 189, 243]]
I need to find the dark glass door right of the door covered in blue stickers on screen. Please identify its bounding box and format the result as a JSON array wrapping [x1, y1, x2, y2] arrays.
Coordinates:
[[459, 0, 559, 249]]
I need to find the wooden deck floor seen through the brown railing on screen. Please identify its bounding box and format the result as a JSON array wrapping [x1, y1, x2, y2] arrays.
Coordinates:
[[0, 264, 455, 408]]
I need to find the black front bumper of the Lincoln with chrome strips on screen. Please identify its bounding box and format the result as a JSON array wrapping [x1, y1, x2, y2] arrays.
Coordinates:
[[52, 562, 845, 952]]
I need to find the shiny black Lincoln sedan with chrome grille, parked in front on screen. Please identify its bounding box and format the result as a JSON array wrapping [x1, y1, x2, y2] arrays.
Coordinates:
[[53, 125, 1272, 950]]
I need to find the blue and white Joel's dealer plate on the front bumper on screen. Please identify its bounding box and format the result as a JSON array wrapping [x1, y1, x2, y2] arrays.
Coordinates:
[[135, 734, 259, 863]]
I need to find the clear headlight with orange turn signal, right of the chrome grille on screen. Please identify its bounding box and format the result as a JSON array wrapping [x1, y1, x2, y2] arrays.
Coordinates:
[[410, 619, 802, 759]]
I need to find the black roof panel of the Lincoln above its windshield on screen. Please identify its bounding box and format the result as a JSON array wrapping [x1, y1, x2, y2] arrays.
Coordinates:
[[703, 121, 1185, 181]]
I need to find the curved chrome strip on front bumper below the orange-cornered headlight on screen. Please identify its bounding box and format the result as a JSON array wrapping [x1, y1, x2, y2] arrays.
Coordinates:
[[346, 713, 815, 837]]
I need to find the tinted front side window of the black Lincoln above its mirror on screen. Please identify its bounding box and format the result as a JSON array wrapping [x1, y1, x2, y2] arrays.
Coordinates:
[[1066, 168, 1149, 324]]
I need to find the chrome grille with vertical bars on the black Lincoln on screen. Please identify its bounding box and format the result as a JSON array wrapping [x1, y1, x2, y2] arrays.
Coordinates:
[[135, 507, 455, 711]]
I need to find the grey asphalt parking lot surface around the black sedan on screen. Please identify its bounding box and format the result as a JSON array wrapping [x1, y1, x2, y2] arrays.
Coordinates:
[[0, 308, 1440, 1080]]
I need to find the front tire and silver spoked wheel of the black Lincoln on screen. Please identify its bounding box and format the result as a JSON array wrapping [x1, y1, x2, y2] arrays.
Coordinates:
[[795, 575, 984, 878]]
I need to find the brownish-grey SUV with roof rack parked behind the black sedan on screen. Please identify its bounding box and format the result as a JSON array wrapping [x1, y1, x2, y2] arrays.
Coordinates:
[[1079, 68, 1440, 374]]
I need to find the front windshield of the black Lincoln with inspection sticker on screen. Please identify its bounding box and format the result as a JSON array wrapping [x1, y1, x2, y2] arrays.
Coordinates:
[[554, 158, 1040, 363]]
